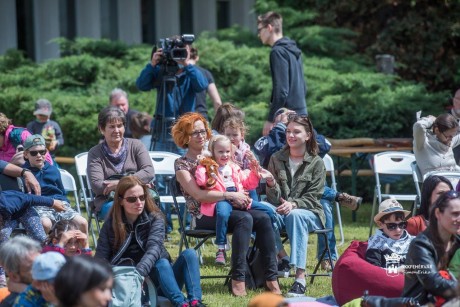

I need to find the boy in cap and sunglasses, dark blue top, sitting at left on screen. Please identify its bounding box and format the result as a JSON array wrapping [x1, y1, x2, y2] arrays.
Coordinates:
[[24, 134, 88, 233]]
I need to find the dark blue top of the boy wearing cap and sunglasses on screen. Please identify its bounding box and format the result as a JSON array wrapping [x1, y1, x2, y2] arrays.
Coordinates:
[[23, 161, 69, 202]]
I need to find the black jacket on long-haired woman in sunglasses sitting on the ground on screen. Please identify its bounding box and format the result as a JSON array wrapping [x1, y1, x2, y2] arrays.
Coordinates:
[[94, 211, 171, 276]]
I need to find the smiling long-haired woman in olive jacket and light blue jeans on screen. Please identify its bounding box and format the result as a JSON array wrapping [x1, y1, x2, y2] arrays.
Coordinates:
[[266, 114, 326, 296]]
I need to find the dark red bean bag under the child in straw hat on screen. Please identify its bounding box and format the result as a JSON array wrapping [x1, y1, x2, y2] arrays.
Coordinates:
[[332, 241, 404, 305]]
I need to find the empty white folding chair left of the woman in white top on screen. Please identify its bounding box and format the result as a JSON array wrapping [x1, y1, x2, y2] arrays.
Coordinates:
[[369, 151, 417, 237]]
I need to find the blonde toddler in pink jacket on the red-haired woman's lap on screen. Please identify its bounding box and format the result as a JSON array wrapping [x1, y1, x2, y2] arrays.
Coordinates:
[[195, 135, 274, 265]]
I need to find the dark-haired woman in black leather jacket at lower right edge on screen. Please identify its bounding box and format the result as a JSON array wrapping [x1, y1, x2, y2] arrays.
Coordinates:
[[402, 191, 460, 306]]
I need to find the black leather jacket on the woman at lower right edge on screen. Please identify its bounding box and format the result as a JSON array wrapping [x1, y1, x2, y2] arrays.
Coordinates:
[[402, 230, 460, 304]]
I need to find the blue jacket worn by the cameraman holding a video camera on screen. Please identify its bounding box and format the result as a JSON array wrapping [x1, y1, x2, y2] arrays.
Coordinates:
[[136, 63, 208, 118]]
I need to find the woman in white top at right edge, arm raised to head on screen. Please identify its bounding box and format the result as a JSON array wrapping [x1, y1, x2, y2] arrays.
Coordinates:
[[413, 113, 460, 176]]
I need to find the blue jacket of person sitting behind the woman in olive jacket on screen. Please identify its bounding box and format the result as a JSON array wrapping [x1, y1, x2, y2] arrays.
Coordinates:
[[254, 123, 331, 168]]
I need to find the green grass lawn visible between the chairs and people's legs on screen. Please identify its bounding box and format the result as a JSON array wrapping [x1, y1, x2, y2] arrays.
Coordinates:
[[84, 204, 409, 307]]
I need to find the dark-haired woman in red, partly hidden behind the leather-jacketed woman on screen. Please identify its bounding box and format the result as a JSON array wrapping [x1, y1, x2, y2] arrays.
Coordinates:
[[407, 175, 454, 236]]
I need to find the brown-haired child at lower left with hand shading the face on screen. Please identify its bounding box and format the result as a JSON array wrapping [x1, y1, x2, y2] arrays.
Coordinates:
[[42, 220, 92, 257]]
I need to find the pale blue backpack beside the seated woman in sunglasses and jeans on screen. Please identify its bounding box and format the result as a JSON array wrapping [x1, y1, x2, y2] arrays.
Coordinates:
[[110, 266, 157, 307]]
